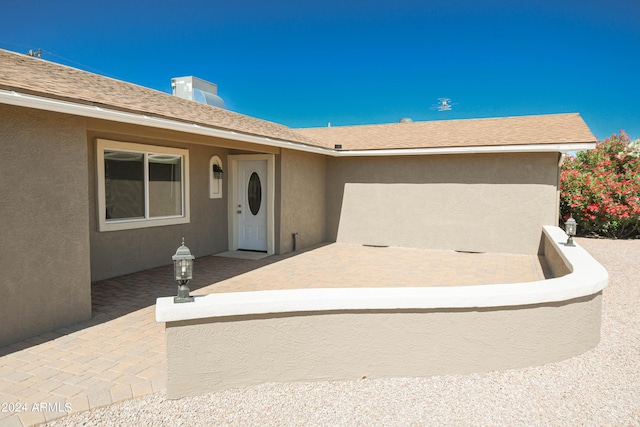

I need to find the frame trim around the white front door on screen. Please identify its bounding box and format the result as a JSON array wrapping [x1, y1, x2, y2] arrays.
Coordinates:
[[225, 154, 276, 255]]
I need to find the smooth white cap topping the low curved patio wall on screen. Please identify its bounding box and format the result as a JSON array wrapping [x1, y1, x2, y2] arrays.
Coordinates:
[[156, 226, 609, 322]]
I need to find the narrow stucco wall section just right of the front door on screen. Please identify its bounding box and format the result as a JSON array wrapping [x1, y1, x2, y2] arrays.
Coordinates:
[[276, 150, 326, 253]]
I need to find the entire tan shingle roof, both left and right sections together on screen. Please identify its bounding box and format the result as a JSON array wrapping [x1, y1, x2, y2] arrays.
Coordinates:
[[0, 49, 596, 150]]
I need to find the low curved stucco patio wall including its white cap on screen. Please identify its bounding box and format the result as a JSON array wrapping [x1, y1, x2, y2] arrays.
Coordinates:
[[156, 227, 608, 398]]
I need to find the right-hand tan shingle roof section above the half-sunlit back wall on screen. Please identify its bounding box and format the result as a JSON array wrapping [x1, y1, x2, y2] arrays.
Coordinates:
[[296, 113, 596, 150]]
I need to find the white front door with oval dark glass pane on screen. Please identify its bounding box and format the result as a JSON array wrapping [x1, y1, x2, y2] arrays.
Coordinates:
[[236, 160, 268, 252]]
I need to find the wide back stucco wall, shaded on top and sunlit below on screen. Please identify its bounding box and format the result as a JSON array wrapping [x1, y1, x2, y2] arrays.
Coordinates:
[[327, 153, 558, 254]]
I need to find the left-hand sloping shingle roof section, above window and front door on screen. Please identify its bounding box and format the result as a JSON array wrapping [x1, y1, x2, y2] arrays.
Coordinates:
[[0, 49, 317, 145]]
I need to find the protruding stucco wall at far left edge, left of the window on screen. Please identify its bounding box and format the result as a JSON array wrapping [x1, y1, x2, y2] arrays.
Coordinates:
[[0, 105, 91, 345]]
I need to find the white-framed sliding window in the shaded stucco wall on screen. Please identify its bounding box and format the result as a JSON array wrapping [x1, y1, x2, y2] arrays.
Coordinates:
[[96, 139, 189, 231]]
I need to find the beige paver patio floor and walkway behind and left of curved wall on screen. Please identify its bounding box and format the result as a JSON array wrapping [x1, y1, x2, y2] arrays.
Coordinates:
[[0, 244, 547, 427]]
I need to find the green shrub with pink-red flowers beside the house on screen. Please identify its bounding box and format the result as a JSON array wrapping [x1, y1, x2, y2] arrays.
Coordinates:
[[560, 130, 640, 238]]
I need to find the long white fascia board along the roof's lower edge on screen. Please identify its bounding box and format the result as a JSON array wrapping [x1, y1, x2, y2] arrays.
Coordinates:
[[0, 89, 596, 157]]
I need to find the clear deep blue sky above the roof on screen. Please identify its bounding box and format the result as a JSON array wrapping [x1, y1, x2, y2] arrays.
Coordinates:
[[0, 0, 640, 139]]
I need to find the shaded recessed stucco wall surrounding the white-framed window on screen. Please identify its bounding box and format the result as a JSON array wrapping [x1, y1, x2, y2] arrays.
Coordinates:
[[85, 121, 229, 282]]
